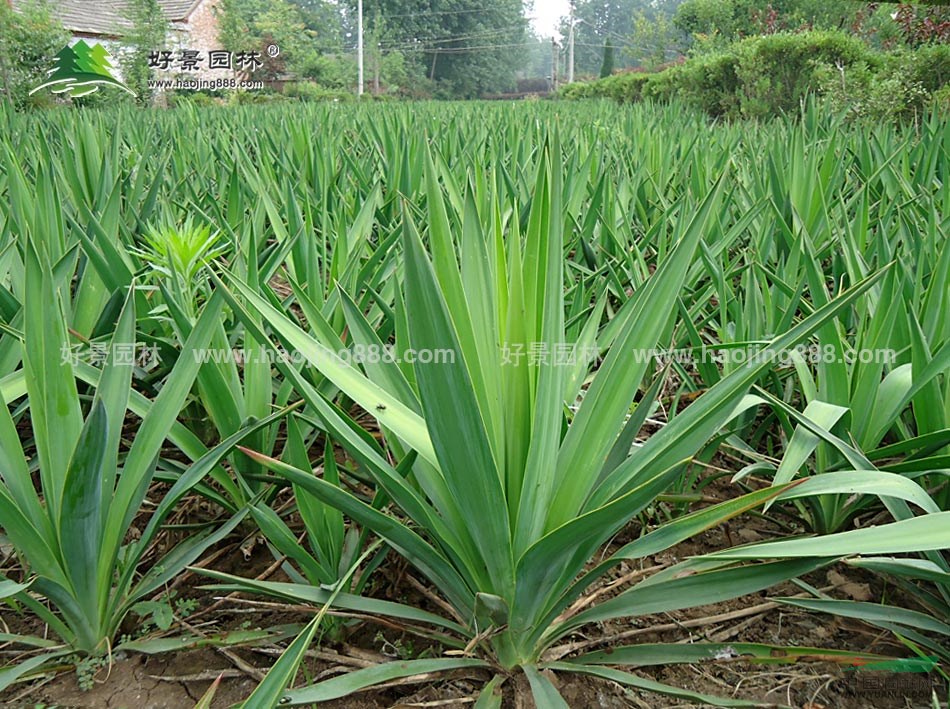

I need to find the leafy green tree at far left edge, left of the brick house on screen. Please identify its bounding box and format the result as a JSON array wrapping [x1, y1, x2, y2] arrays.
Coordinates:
[[0, 0, 69, 108]]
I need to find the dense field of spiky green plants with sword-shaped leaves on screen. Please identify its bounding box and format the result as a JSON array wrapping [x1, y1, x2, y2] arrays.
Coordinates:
[[0, 102, 950, 709]]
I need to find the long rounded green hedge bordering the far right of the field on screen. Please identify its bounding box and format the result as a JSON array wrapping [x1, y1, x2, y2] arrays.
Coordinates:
[[561, 31, 950, 118]]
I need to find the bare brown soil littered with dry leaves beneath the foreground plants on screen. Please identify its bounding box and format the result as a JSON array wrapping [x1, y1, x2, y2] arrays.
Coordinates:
[[0, 484, 946, 709]]
